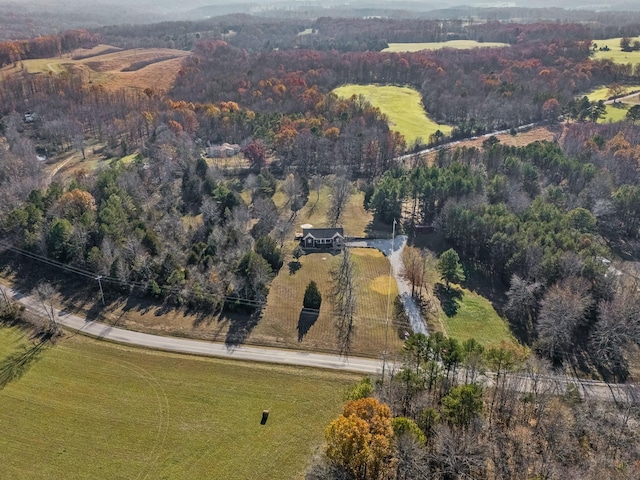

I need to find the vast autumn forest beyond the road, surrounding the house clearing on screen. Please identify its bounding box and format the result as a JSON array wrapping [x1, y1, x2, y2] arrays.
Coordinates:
[[0, 15, 640, 380]]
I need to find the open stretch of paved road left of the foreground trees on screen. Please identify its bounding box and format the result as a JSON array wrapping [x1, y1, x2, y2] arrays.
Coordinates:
[[0, 285, 382, 375]]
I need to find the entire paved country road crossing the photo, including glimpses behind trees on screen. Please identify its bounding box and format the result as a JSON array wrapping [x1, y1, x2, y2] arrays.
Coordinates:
[[0, 285, 640, 403]]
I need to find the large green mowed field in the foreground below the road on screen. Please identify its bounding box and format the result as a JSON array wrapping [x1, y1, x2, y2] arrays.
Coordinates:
[[0, 329, 358, 480]]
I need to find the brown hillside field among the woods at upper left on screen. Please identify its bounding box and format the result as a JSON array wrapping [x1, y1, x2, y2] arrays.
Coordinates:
[[0, 45, 191, 91]]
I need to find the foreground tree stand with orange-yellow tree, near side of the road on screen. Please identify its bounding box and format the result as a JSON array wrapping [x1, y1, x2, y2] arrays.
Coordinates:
[[305, 334, 640, 480]]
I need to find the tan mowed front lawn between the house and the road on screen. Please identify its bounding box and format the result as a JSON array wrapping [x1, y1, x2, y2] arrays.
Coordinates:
[[258, 248, 402, 357]]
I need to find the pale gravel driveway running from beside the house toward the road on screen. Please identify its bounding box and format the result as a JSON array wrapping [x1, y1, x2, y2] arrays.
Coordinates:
[[346, 235, 429, 335]]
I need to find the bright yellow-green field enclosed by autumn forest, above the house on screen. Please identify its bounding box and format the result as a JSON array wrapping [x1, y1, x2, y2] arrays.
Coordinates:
[[334, 85, 451, 144]]
